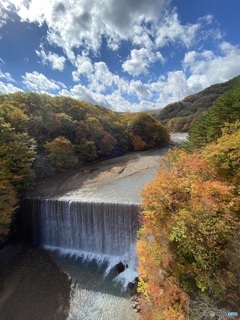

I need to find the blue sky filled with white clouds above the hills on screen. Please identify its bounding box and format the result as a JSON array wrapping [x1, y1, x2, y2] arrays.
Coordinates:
[[0, 0, 240, 112]]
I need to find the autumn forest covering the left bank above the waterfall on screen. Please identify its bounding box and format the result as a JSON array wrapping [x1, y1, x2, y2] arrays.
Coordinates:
[[0, 92, 169, 242]]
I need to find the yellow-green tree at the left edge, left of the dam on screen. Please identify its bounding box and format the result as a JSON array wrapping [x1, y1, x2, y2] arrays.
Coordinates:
[[0, 117, 35, 241]]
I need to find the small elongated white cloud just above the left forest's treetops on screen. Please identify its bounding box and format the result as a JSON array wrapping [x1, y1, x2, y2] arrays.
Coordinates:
[[22, 71, 65, 93]]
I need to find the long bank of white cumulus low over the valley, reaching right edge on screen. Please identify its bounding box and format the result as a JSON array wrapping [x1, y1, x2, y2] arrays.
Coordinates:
[[50, 42, 240, 112]]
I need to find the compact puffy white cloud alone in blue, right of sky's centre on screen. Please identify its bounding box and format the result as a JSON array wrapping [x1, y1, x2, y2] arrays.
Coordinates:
[[122, 48, 164, 76]]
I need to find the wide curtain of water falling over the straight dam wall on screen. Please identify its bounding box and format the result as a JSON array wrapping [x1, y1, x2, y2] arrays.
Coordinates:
[[24, 199, 139, 263]]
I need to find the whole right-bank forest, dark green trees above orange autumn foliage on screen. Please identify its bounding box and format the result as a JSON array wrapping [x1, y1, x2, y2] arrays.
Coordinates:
[[137, 79, 240, 320]]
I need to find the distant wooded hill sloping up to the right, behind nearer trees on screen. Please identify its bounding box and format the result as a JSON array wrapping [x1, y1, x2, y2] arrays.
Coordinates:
[[152, 76, 240, 132]]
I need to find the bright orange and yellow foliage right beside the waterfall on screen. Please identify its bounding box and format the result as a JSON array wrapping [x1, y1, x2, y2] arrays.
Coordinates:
[[137, 129, 240, 320]]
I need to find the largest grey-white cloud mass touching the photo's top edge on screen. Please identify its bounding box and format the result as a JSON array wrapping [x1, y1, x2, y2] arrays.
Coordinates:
[[5, 0, 169, 57]]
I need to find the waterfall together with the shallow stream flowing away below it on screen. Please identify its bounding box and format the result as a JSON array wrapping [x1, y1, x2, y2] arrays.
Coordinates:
[[23, 198, 140, 320]]
